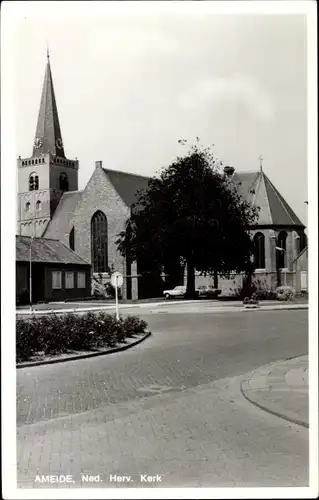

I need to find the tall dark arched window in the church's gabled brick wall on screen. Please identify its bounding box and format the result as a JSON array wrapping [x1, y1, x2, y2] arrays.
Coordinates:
[[91, 210, 108, 273]]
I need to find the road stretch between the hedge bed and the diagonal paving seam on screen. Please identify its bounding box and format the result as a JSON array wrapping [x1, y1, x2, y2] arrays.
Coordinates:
[[17, 308, 308, 424]]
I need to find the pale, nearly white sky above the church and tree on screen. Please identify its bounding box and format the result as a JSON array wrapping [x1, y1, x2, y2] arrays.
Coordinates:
[[3, 2, 314, 224]]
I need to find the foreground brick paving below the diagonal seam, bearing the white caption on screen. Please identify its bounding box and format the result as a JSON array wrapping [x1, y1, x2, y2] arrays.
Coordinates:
[[18, 377, 308, 488]]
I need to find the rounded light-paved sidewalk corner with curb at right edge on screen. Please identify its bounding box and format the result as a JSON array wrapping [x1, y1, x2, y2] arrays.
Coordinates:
[[242, 356, 309, 427]]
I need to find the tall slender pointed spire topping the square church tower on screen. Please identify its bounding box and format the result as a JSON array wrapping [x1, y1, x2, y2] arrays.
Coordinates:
[[33, 52, 65, 158]]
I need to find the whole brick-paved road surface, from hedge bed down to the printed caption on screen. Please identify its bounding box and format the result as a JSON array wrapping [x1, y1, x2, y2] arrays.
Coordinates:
[[17, 306, 308, 487]]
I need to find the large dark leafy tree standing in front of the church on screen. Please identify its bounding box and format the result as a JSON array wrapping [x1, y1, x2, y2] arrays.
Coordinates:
[[117, 141, 258, 296]]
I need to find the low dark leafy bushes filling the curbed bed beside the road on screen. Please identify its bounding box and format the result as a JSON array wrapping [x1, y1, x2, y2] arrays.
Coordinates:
[[16, 312, 147, 363]]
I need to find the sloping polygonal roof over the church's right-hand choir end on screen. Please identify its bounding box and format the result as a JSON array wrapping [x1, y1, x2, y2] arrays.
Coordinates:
[[233, 169, 305, 228]]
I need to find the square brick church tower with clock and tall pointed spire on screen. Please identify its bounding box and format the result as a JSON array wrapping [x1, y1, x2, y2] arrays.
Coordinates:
[[17, 53, 79, 237]]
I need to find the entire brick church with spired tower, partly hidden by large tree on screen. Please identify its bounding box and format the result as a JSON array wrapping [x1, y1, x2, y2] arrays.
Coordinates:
[[17, 56, 306, 299]]
